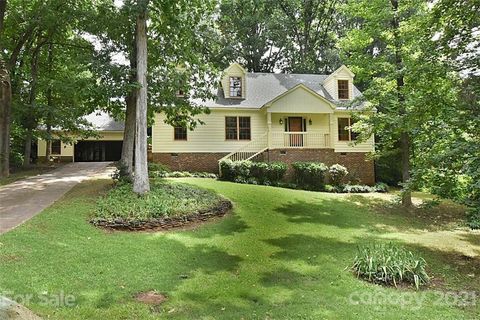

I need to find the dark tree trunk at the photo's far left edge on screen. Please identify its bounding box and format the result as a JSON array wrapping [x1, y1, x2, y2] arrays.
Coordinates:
[[0, 0, 12, 177]]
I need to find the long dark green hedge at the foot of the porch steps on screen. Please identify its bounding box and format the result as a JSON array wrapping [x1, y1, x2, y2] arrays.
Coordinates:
[[220, 160, 287, 185]]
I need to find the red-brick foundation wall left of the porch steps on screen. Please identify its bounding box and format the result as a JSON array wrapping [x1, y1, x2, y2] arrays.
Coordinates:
[[152, 153, 227, 173]]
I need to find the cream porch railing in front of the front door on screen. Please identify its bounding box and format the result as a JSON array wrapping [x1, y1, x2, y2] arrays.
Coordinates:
[[270, 132, 330, 148]]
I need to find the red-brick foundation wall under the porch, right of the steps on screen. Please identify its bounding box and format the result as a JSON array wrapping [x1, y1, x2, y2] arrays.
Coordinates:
[[266, 149, 375, 185]]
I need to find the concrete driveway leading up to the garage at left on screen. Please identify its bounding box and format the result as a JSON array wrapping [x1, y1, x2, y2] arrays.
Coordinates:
[[0, 162, 113, 234]]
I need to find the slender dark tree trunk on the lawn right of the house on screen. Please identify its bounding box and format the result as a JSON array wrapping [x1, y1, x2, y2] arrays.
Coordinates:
[[390, 0, 412, 207]]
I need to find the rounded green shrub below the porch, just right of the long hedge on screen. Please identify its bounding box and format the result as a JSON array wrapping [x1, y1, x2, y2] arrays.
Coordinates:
[[292, 162, 328, 190]]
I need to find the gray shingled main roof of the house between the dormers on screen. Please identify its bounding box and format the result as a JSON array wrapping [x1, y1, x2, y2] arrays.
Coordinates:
[[195, 72, 361, 108]]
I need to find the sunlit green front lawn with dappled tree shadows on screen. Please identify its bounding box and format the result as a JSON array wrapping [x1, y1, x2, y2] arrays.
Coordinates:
[[0, 179, 480, 320]]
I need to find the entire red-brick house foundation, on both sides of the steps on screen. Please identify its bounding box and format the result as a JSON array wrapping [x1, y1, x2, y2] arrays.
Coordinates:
[[152, 149, 375, 185]]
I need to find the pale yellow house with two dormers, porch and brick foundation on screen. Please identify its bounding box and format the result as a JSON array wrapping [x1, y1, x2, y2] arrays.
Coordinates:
[[152, 63, 375, 184]]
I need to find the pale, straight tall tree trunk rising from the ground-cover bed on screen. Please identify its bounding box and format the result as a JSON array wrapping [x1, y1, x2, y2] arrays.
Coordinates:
[[133, 0, 150, 194]]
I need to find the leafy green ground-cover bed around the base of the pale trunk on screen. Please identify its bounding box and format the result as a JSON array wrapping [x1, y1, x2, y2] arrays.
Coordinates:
[[95, 180, 228, 221]]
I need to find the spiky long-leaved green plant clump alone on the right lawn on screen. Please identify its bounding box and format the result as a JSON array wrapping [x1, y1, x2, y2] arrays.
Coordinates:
[[351, 244, 430, 289]]
